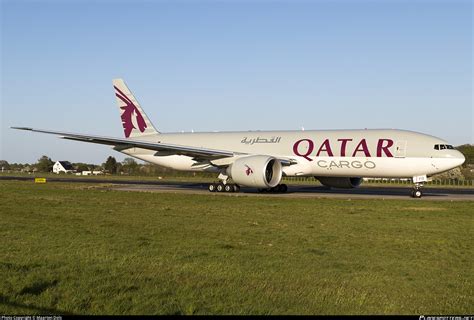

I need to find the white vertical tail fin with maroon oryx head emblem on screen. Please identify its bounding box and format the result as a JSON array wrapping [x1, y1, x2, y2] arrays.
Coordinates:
[[112, 79, 159, 138]]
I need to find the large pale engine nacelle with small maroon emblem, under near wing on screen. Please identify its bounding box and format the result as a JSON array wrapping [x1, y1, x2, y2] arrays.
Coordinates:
[[227, 155, 282, 188]]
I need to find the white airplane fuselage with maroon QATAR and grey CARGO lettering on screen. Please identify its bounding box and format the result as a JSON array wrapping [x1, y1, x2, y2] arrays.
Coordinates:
[[120, 129, 464, 178]]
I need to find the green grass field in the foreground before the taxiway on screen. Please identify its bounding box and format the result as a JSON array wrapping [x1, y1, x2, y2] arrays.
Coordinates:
[[0, 181, 474, 314]]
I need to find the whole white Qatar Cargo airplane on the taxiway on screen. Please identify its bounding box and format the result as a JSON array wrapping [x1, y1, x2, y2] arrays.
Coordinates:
[[13, 79, 465, 198]]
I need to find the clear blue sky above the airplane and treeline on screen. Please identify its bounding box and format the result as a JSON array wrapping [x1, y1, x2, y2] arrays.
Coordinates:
[[0, 0, 474, 163]]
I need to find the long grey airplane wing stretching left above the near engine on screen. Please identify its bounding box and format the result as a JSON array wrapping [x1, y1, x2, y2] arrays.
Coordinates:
[[12, 127, 293, 165]]
